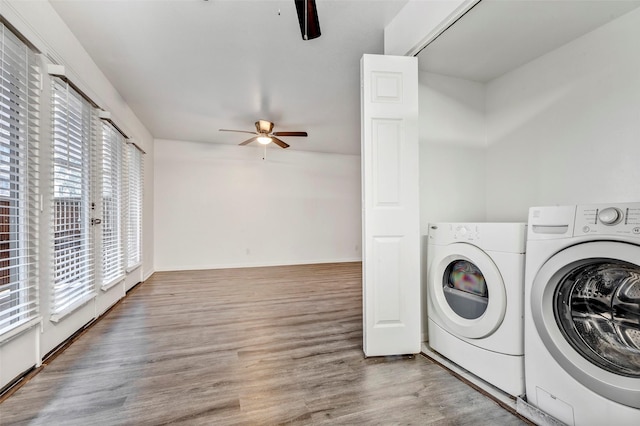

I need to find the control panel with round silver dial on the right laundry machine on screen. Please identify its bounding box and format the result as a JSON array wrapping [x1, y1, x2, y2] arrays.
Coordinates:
[[574, 203, 640, 238]]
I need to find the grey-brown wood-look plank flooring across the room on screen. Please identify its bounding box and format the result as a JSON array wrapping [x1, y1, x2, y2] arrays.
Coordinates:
[[0, 263, 527, 426]]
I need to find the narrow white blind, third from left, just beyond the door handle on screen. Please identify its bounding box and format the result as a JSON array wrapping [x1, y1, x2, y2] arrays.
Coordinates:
[[101, 123, 125, 289]]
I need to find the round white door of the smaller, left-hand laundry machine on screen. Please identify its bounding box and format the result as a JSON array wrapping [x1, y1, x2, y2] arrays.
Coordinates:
[[427, 243, 507, 339]]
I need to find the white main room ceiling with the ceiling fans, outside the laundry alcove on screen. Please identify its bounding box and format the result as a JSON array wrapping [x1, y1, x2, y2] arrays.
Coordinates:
[[50, 0, 406, 154]]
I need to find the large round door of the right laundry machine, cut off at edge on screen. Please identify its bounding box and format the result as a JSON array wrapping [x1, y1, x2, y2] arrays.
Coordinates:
[[530, 241, 640, 408]]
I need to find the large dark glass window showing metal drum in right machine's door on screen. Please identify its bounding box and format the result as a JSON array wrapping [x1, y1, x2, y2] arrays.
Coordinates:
[[554, 259, 640, 378]]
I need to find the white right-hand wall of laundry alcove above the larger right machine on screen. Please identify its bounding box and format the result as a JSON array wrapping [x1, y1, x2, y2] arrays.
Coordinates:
[[486, 6, 640, 221]]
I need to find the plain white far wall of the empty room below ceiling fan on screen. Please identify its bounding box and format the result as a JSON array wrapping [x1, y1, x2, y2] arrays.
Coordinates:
[[155, 140, 361, 270]]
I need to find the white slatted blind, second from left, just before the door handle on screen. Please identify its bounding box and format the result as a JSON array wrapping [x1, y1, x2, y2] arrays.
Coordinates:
[[51, 78, 97, 321]]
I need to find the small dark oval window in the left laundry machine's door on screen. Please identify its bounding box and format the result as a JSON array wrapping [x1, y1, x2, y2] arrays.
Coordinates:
[[442, 260, 489, 319]]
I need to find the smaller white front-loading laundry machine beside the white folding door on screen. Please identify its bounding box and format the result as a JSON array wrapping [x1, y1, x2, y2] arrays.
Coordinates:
[[427, 223, 527, 396]]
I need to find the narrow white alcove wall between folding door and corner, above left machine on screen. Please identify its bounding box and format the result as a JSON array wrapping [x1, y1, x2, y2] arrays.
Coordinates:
[[419, 72, 486, 234]]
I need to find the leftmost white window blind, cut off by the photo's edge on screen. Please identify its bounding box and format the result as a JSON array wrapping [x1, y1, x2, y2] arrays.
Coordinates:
[[0, 23, 40, 335]]
